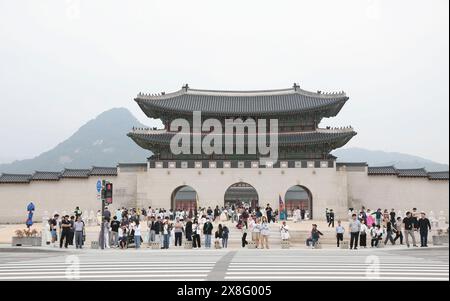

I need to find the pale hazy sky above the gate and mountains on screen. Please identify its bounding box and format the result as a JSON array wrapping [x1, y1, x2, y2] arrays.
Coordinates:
[[0, 0, 449, 163]]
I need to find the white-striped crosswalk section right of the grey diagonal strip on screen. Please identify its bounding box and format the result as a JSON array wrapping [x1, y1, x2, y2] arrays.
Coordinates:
[[225, 255, 449, 281]]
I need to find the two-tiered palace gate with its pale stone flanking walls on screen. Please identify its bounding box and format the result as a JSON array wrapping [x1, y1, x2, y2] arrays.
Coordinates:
[[0, 84, 449, 223]]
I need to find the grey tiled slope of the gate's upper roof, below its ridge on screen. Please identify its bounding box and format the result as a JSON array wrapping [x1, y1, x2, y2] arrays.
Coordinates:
[[134, 94, 349, 118]]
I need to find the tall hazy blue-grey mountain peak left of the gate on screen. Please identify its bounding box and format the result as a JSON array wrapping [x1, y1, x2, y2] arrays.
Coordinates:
[[0, 108, 150, 173]]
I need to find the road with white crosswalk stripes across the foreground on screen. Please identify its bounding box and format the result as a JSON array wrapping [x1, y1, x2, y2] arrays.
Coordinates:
[[0, 247, 449, 281]]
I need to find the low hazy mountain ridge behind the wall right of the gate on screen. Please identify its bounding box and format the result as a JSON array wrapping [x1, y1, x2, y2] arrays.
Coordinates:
[[333, 147, 448, 171]]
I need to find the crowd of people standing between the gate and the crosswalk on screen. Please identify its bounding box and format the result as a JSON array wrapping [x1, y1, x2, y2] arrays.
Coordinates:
[[47, 204, 440, 250]]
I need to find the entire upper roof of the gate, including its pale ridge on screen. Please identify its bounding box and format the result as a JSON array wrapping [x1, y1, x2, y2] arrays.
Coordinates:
[[135, 85, 348, 118]]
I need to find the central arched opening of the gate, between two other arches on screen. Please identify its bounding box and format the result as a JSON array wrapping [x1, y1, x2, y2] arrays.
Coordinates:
[[224, 182, 259, 208]]
